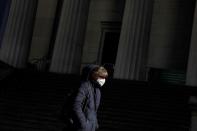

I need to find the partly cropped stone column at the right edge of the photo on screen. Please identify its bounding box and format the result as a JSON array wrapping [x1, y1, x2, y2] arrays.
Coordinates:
[[186, 2, 197, 86]]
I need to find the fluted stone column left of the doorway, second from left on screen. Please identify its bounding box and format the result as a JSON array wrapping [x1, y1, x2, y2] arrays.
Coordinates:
[[50, 0, 89, 74]]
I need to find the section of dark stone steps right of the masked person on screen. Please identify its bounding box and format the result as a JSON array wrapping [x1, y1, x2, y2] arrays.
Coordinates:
[[99, 80, 190, 131]]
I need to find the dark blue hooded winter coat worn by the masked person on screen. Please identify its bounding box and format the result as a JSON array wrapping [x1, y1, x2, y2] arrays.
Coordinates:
[[69, 65, 101, 131]]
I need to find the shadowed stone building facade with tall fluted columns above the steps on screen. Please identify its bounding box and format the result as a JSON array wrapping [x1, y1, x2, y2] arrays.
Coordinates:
[[0, 0, 197, 86]]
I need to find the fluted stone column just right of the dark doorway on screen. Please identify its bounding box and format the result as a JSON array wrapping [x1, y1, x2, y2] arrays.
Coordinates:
[[114, 0, 153, 80]]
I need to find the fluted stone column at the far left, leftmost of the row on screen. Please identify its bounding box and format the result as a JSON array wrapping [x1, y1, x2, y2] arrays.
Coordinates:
[[0, 0, 37, 68]]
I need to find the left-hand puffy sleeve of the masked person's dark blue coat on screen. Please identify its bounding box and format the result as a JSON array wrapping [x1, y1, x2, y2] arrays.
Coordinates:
[[73, 85, 86, 128]]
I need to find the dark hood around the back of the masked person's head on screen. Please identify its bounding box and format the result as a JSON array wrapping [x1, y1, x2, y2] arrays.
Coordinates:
[[81, 64, 99, 81]]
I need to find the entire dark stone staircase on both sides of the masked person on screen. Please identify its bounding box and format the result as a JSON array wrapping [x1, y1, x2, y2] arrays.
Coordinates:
[[0, 70, 191, 131]]
